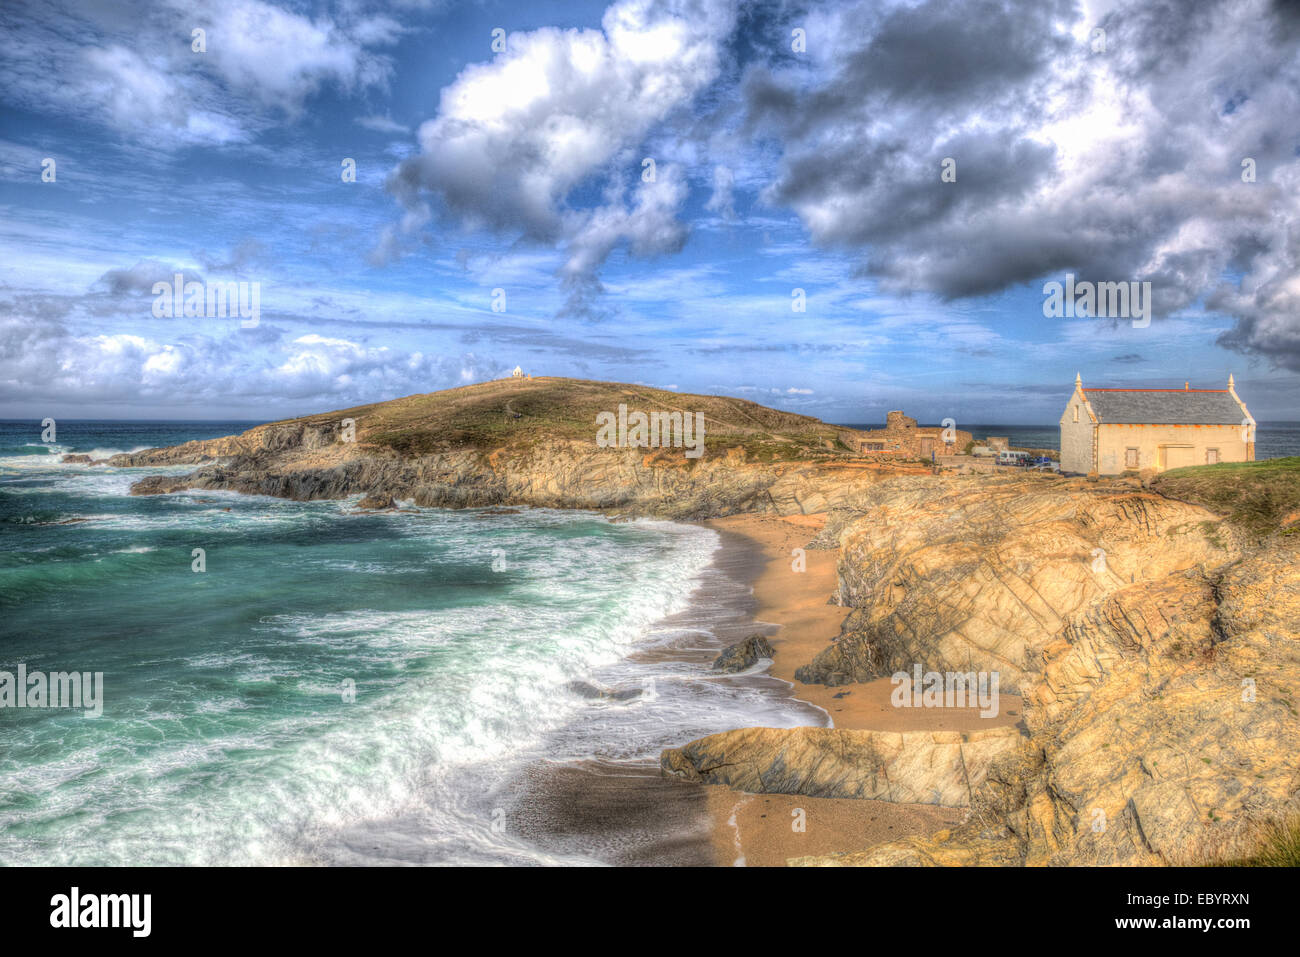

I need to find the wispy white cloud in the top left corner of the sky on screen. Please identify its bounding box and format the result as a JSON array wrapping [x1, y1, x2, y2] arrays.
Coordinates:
[[0, 0, 403, 148]]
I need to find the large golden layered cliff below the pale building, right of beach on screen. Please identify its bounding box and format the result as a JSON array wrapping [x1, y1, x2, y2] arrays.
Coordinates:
[[780, 480, 1300, 865]]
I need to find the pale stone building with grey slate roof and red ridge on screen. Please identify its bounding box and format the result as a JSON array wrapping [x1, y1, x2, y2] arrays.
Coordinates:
[[1061, 376, 1255, 475]]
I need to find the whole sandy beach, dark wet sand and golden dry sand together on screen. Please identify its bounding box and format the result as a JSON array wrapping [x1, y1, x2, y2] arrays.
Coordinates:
[[510, 515, 1021, 867]]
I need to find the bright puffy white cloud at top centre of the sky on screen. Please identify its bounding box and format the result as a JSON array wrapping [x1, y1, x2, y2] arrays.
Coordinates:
[[379, 0, 735, 291]]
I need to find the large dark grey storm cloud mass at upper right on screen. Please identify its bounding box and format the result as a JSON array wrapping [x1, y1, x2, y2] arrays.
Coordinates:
[[742, 0, 1300, 369]]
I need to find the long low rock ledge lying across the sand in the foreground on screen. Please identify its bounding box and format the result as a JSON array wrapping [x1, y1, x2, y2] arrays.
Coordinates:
[[659, 727, 1021, 807]]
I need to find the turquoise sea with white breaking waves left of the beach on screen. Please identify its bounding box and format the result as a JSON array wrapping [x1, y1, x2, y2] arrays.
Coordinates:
[[0, 423, 806, 865]]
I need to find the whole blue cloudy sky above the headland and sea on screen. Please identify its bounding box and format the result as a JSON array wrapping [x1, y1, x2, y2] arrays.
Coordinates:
[[0, 0, 1300, 425]]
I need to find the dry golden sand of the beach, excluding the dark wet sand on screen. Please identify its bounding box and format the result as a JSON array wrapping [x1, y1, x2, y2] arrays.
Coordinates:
[[705, 515, 1021, 866]]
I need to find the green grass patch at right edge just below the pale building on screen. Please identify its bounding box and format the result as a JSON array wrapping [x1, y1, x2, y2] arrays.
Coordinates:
[[1152, 456, 1300, 536]]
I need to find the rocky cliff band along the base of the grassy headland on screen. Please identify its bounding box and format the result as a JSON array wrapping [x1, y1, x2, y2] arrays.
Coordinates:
[[109, 423, 920, 518]]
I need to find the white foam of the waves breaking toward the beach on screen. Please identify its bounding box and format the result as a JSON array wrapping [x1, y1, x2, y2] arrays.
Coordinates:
[[0, 504, 743, 863]]
